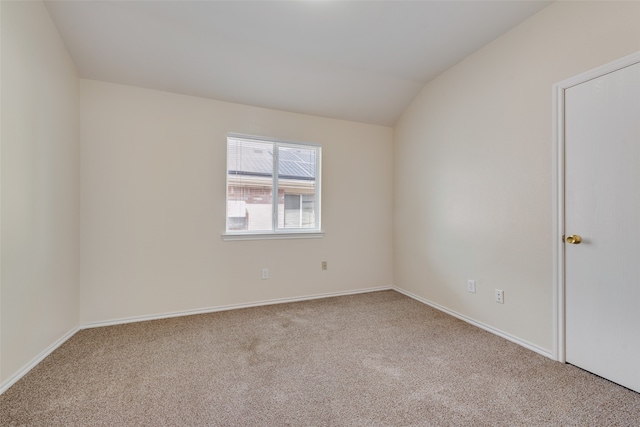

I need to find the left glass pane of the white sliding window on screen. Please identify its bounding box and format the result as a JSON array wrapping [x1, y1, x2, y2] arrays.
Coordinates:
[[227, 138, 273, 231]]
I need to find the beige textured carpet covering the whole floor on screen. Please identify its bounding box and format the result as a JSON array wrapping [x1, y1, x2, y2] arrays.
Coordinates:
[[0, 291, 640, 426]]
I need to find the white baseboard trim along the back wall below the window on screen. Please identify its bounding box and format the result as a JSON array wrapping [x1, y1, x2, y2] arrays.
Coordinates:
[[80, 286, 394, 329]]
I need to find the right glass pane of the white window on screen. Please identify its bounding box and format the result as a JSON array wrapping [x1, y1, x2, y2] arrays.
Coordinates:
[[278, 145, 318, 229]]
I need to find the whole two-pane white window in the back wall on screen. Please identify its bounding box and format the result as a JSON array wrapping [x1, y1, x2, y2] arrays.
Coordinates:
[[226, 135, 321, 236]]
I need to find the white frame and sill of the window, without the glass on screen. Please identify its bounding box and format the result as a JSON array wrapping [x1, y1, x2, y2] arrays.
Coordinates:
[[222, 133, 324, 241]]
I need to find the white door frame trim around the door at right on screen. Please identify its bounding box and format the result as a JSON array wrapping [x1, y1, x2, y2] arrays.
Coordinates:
[[552, 51, 640, 363]]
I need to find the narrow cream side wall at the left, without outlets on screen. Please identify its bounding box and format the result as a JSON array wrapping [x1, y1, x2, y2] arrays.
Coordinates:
[[0, 1, 80, 385]]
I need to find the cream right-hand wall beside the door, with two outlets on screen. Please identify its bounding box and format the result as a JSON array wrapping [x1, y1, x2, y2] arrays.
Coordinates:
[[394, 2, 640, 352]]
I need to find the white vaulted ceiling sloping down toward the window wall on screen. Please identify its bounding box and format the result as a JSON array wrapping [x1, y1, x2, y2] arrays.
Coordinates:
[[46, 0, 551, 126]]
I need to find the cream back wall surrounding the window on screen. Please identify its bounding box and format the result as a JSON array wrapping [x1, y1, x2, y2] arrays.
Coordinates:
[[80, 80, 393, 323]]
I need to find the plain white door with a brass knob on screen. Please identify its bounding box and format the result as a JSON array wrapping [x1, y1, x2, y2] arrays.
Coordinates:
[[564, 63, 640, 392]]
